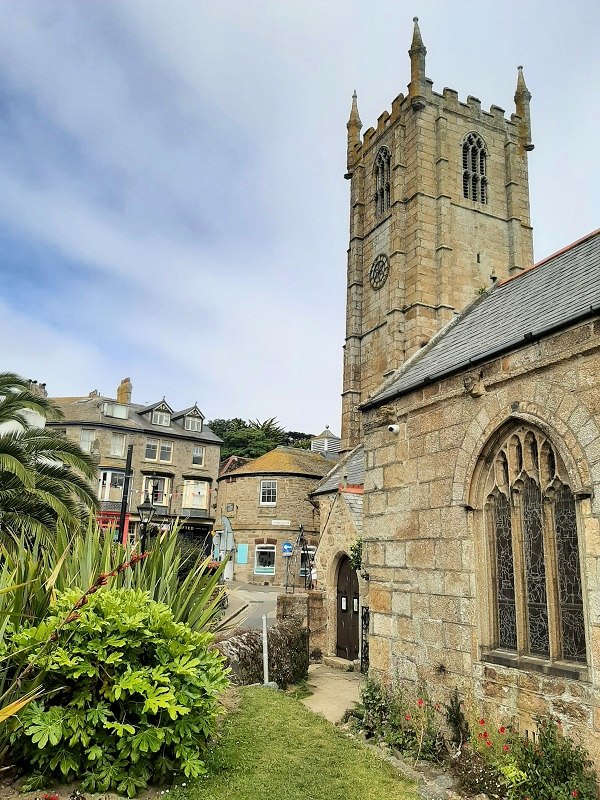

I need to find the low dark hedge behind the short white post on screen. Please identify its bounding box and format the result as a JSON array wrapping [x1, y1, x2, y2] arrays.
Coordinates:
[[217, 625, 308, 689]]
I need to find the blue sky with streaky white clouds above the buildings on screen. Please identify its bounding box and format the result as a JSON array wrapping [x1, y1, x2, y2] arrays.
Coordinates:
[[0, 0, 600, 433]]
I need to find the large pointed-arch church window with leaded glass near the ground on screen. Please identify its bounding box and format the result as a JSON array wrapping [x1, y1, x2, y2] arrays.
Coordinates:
[[485, 426, 586, 662]]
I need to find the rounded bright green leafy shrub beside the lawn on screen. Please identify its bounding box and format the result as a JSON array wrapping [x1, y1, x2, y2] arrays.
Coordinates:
[[2, 589, 228, 797]]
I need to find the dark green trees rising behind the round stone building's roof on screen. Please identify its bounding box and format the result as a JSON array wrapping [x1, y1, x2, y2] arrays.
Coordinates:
[[207, 417, 311, 459]]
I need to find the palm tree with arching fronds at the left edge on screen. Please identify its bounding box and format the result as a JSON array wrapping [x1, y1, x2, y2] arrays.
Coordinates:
[[0, 372, 97, 537]]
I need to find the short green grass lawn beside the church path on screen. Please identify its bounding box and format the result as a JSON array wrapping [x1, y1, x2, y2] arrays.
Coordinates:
[[165, 688, 417, 800]]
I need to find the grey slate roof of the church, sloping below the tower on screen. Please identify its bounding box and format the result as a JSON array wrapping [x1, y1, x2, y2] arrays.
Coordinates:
[[361, 230, 600, 408]]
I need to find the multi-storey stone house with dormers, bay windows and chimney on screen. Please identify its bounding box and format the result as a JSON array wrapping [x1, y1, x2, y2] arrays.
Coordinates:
[[48, 378, 221, 552]]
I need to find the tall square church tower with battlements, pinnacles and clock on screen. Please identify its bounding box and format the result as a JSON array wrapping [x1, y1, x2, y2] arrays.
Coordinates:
[[342, 17, 533, 450]]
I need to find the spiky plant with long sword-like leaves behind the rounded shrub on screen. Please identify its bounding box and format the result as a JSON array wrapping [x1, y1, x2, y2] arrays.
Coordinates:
[[0, 520, 230, 762]]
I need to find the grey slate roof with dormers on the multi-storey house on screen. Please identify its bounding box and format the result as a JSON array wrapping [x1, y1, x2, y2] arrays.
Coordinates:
[[47, 395, 223, 444]]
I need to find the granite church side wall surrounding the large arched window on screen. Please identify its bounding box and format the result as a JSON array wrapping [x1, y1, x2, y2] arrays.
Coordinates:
[[363, 320, 600, 763]]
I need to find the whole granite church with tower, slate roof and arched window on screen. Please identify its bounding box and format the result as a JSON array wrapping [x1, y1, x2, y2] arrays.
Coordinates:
[[317, 20, 600, 763]]
